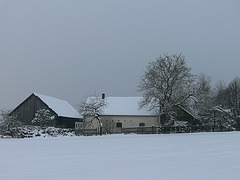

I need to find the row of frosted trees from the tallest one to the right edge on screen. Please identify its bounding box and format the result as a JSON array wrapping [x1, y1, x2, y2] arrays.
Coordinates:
[[138, 54, 240, 130]]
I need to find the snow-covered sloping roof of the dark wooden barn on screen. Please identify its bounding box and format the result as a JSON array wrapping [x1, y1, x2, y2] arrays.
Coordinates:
[[34, 93, 82, 118]]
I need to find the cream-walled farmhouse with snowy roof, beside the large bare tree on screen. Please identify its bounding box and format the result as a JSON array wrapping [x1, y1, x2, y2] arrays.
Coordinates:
[[76, 97, 159, 133]]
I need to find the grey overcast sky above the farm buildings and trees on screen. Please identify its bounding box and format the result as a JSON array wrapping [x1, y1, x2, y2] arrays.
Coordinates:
[[0, 0, 240, 109]]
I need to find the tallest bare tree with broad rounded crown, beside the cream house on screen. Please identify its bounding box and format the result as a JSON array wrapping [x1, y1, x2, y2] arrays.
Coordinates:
[[138, 54, 195, 125]]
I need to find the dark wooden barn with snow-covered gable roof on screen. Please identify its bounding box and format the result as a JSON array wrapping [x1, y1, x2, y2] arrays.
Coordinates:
[[10, 93, 83, 128]]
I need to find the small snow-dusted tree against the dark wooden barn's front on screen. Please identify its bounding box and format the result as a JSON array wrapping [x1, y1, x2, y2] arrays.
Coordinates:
[[32, 109, 55, 127]]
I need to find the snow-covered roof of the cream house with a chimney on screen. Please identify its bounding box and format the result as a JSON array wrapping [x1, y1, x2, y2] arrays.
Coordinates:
[[102, 97, 156, 116]]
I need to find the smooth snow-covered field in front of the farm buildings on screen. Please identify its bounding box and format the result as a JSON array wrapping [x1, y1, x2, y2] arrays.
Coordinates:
[[0, 132, 240, 180]]
